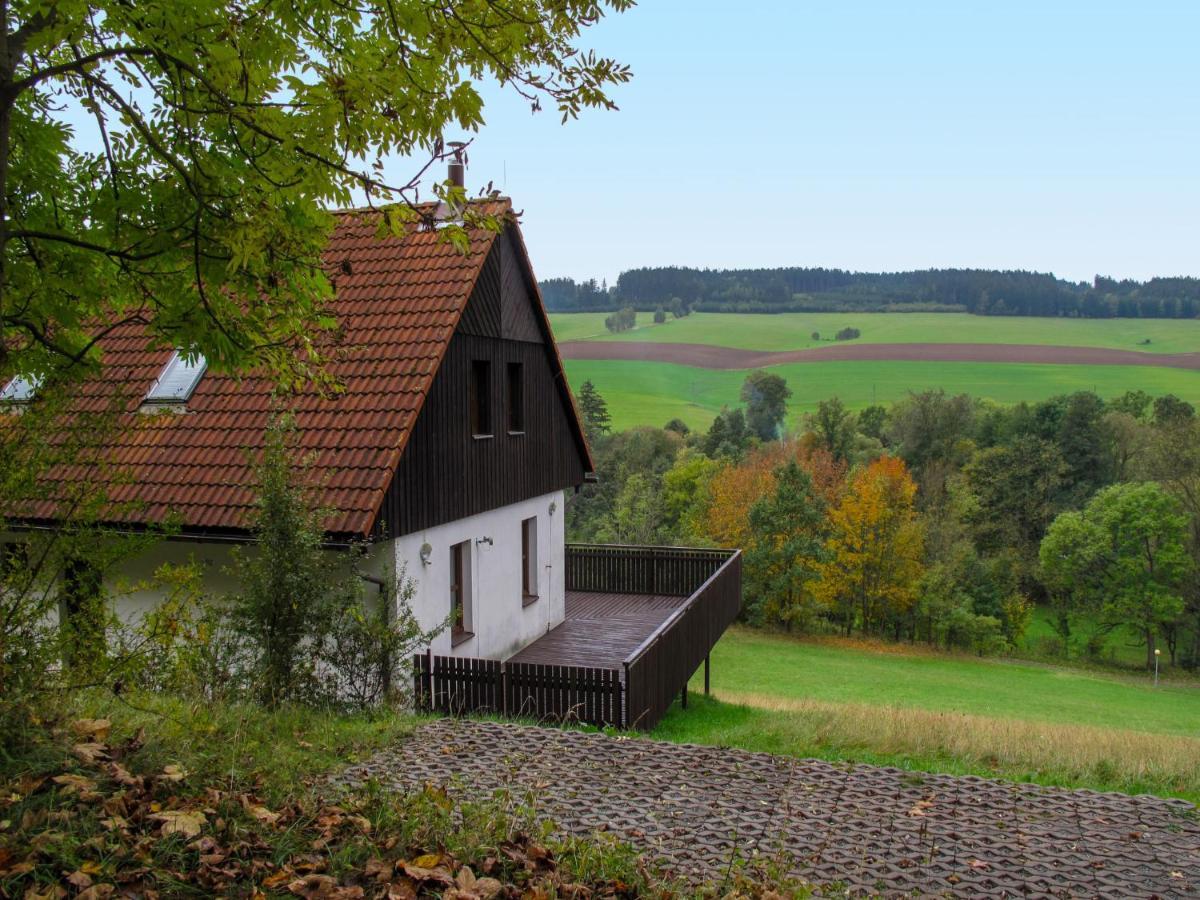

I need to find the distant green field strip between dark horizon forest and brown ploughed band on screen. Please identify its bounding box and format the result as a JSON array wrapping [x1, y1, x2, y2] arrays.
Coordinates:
[[550, 312, 1200, 353]]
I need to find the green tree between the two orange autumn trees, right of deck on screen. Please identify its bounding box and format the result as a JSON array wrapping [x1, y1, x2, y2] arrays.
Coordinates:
[[745, 462, 824, 630]]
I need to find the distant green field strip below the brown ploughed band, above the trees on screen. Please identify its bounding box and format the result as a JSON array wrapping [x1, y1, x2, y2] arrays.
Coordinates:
[[566, 357, 1200, 428]]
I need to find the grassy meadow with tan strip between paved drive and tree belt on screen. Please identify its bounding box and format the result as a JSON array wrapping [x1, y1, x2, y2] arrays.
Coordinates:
[[655, 629, 1200, 800]]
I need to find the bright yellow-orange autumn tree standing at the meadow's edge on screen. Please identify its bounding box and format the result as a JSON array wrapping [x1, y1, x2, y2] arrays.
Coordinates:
[[814, 456, 924, 635]]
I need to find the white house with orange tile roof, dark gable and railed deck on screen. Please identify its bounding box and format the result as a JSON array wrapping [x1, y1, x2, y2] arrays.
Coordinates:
[[2, 190, 740, 734]]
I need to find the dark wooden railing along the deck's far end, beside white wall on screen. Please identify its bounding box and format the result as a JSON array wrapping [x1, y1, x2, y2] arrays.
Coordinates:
[[566, 544, 730, 596]]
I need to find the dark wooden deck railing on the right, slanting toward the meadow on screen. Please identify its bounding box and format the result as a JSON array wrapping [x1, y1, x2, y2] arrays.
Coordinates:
[[625, 551, 742, 731]]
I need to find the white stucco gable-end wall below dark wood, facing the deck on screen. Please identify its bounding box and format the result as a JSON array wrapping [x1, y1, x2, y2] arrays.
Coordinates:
[[394, 491, 565, 659]]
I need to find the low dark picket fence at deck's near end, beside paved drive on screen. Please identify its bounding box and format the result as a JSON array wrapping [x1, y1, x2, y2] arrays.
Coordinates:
[[413, 653, 625, 728]]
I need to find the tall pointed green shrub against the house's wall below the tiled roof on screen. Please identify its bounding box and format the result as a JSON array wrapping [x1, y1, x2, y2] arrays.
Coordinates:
[[214, 416, 446, 709]]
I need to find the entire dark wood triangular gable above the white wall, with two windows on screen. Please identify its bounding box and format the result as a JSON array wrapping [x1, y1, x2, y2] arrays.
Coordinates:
[[376, 225, 584, 535]]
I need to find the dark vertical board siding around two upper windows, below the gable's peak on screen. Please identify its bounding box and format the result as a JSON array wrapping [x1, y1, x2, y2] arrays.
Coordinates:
[[379, 332, 583, 535]]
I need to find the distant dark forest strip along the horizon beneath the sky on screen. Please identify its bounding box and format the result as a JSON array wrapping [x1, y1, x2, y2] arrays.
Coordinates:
[[540, 266, 1200, 319]]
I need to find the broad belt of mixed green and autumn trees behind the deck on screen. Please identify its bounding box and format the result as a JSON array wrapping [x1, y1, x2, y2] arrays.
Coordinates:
[[568, 371, 1200, 668]]
